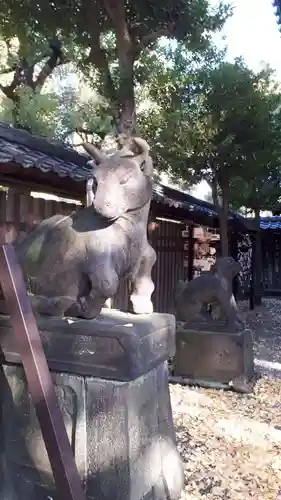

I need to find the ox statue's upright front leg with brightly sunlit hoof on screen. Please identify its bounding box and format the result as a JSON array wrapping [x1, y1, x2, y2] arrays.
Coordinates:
[[130, 245, 156, 314]]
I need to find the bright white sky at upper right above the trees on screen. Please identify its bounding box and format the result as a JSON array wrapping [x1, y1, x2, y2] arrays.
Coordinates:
[[177, 0, 281, 198]]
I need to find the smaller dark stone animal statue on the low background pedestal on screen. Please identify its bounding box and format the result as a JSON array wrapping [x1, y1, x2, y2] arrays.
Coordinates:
[[175, 257, 244, 329]]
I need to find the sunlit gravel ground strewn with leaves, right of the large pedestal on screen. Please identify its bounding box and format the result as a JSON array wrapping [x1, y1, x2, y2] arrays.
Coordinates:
[[170, 299, 281, 500]]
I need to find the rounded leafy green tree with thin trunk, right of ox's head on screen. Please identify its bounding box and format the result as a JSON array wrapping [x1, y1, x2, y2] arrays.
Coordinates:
[[137, 50, 281, 253]]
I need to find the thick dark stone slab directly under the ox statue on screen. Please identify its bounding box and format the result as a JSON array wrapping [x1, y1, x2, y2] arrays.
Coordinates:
[[0, 309, 175, 381]]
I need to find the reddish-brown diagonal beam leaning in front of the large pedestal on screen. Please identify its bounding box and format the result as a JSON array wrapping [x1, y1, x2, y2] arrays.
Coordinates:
[[0, 245, 86, 500]]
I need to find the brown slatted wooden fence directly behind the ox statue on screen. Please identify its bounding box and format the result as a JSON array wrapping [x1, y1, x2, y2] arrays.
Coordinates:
[[0, 189, 187, 312]]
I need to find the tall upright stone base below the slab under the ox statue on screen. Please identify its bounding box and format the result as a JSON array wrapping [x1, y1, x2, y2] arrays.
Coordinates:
[[0, 362, 183, 500]]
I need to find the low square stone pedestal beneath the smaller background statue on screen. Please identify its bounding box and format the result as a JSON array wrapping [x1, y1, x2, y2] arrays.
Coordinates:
[[174, 325, 256, 393]]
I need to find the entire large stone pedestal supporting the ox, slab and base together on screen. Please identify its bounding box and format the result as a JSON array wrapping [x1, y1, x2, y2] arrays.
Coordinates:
[[0, 310, 183, 500]]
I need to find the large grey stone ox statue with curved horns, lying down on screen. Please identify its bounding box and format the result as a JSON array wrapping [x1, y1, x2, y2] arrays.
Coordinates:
[[12, 138, 156, 319]]
